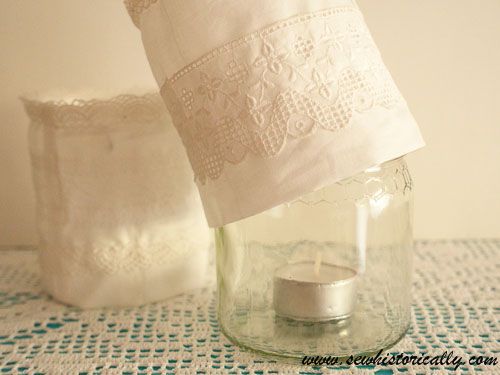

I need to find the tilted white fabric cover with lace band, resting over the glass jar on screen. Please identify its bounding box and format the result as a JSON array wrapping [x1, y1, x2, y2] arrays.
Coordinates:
[[125, 0, 424, 227]]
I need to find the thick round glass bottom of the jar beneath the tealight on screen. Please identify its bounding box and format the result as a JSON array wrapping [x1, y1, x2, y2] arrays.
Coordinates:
[[221, 314, 409, 359]]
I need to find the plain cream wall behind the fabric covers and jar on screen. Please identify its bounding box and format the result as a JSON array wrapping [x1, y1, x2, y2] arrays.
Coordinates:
[[0, 0, 500, 244]]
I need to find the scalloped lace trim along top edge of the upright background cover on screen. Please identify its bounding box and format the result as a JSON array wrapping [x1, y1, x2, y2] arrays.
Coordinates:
[[21, 94, 167, 130]]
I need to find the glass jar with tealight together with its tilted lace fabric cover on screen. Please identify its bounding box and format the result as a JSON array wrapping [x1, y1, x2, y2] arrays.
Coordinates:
[[125, 0, 424, 356]]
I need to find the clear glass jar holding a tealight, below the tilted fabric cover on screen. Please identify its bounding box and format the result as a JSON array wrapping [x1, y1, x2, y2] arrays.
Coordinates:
[[216, 158, 413, 357]]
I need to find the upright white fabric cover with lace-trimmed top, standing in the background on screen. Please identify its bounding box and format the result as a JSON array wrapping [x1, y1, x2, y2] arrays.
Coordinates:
[[24, 94, 210, 307]]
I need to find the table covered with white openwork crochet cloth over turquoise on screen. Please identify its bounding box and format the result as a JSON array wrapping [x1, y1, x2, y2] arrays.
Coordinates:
[[0, 239, 500, 375]]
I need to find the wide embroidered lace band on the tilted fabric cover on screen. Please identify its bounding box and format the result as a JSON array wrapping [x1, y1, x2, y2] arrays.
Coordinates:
[[161, 7, 403, 184]]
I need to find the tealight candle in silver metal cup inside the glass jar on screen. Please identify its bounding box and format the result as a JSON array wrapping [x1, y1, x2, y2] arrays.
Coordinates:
[[273, 262, 357, 322]]
